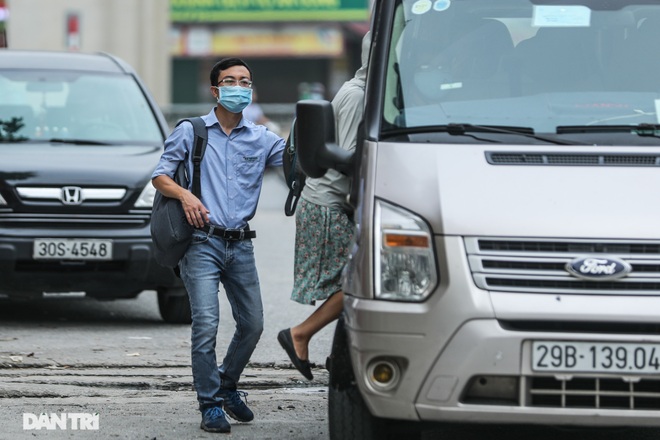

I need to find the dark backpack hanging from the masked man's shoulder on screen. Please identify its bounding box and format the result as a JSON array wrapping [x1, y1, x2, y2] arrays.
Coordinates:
[[150, 117, 208, 268]]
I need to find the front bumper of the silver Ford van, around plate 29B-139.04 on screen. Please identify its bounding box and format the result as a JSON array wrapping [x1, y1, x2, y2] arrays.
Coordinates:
[[346, 306, 660, 426]]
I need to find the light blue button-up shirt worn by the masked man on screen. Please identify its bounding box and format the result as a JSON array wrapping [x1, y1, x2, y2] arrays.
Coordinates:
[[151, 109, 285, 229]]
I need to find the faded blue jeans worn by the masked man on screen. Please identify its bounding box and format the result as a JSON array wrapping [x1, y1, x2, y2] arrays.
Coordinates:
[[180, 231, 264, 409]]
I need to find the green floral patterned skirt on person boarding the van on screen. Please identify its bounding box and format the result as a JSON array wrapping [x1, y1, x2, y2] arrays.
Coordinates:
[[291, 199, 353, 305]]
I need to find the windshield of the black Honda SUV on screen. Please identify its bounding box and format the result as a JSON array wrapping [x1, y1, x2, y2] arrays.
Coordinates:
[[0, 70, 162, 144]]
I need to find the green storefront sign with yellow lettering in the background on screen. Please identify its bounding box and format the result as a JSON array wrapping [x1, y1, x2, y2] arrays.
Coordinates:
[[170, 0, 369, 23]]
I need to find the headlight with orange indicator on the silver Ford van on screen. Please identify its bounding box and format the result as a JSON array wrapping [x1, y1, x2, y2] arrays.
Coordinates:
[[374, 200, 438, 301]]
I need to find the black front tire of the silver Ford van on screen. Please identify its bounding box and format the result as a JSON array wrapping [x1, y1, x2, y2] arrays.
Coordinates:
[[327, 317, 421, 440]]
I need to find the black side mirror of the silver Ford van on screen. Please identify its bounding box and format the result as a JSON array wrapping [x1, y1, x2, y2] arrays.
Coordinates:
[[295, 99, 355, 178]]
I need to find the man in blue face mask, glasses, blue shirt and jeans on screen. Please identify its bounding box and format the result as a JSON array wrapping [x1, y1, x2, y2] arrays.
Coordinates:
[[152, 58, 285, 432]]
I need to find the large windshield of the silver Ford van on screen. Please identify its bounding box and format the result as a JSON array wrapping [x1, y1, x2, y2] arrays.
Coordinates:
[[383, 0, 660, 144]]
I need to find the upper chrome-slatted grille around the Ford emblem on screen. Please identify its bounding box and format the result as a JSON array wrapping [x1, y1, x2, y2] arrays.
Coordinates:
[[465, 237, 660, 295]]
